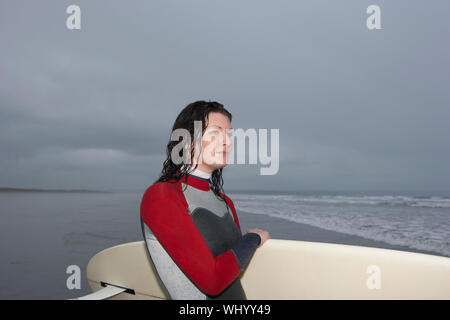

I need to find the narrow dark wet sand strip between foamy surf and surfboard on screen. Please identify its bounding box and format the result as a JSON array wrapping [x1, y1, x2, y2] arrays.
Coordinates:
[[236, 210, 448, 258]]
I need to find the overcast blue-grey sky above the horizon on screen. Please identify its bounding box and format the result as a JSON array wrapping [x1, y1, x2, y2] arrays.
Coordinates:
[[0, 0, 450, 196]]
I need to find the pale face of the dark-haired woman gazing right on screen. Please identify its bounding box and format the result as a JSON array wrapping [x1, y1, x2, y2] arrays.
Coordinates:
[[193, 112, 232, 173]]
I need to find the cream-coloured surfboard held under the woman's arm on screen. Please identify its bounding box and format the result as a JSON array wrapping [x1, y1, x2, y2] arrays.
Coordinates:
[[81, 239, 450, 300]]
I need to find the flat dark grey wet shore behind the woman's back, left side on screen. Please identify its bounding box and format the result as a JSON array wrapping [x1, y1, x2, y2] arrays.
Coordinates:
[[0, 192, 143, 299]]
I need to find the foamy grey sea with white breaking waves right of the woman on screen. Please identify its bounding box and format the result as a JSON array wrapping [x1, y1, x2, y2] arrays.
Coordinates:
[[230, 193, 450, 257]]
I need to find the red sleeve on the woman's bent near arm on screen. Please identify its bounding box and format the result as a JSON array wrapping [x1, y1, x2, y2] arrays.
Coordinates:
[[140, 182, 240, 296]]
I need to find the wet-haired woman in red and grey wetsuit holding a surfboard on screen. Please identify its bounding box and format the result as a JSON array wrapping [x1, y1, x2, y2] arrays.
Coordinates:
[[141, 101, 270, 299]]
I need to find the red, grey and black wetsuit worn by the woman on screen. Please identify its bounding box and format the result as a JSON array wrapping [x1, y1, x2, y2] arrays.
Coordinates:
[[140, 174, 261, 299]]
